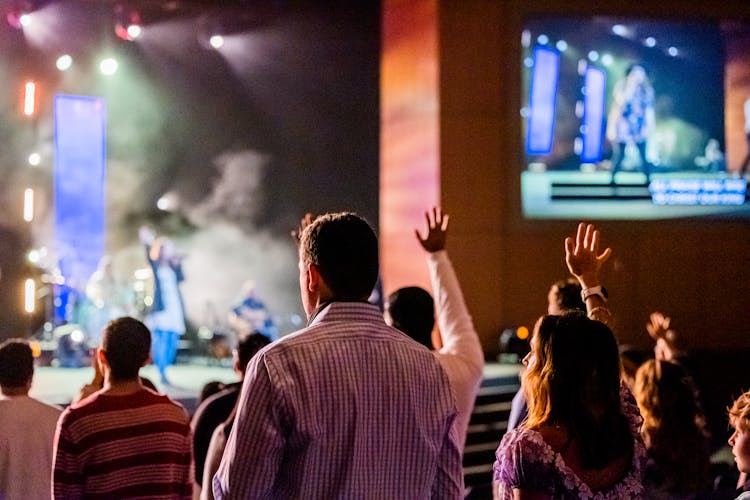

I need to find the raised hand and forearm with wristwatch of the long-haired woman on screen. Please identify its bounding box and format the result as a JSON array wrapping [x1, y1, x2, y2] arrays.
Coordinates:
[[565, 222, 612, 323]]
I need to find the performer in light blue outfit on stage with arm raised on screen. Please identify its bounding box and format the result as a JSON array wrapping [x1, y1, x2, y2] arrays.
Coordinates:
[[139, 227, 185, 384]]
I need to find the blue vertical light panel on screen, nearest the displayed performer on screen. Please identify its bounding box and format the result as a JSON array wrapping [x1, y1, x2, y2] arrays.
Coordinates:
[[581, 66, 607, 163]]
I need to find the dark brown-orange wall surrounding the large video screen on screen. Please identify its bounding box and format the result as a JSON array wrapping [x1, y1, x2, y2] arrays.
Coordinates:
[[439, 0, 750, 356]]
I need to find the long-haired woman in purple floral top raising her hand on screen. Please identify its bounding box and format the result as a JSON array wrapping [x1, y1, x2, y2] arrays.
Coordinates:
[[494, 224, 645, 499]]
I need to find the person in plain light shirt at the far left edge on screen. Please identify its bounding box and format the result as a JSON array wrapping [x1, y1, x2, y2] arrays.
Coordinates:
[[0, 339, 62, 499]]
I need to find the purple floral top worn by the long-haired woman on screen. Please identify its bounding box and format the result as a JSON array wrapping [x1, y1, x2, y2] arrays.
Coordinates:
[[494, 385, 646, 500]]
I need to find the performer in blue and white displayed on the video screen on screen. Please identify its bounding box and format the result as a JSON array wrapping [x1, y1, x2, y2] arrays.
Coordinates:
[[607, 64, 655, 184]]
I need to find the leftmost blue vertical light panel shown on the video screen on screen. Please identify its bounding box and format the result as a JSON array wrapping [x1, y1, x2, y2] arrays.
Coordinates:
[[526, 47, 560, 155]]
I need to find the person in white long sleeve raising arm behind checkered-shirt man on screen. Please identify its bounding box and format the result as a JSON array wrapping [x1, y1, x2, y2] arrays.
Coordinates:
[[385, 208, 484, 453]]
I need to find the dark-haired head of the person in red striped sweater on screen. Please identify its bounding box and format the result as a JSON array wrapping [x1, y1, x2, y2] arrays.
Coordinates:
[[102, 317, 151, 381]]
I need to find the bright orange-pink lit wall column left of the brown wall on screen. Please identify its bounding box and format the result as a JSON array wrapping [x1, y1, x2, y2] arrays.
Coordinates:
[[380, 0, 440, 294]]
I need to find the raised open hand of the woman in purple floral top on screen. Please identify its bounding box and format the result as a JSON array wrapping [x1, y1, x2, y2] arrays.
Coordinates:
[[565, 222, 612, 288]]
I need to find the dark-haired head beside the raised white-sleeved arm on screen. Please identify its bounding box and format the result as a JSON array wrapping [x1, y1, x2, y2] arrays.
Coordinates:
[[386, 286, 435, 349]]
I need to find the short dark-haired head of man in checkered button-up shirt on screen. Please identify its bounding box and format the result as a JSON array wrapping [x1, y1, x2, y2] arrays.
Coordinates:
[[300, 212, 378, 299]]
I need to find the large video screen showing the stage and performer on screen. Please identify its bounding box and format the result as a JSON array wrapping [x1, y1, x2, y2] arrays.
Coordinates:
[[521, 15, 750, 219]]
